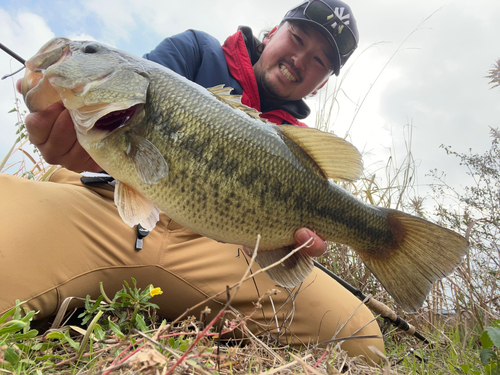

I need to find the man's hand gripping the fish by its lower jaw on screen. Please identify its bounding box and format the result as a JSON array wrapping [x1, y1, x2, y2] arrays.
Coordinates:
[[17, 80, 102, 172]]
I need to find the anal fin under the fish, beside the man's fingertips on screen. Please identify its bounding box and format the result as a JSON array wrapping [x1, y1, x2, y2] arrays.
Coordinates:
[[255, 246, 314, 288]]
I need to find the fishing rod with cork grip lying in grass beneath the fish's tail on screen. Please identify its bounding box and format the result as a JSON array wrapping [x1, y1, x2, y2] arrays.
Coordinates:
[[313, 260, 432, 344]]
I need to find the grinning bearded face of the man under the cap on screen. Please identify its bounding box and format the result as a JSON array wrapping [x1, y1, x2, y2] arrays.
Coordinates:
[[253, 22, 333, 101]]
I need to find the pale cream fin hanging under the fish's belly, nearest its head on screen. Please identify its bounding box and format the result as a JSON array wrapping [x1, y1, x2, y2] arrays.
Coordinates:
[[115, 181, 160, 231]]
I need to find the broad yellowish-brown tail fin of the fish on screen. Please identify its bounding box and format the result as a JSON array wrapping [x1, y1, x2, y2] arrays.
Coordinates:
[[359, 207, 469, 312]]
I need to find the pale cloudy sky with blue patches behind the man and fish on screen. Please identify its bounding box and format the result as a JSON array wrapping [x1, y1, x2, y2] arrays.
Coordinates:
[[0, 0, 500, 209]]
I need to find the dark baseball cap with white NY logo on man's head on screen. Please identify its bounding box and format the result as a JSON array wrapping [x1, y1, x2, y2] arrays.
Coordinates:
[[281, 0, 359, 76]]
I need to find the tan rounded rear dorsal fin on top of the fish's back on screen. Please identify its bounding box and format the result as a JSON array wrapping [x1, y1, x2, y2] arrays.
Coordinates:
[[278, 125, 363, 181]]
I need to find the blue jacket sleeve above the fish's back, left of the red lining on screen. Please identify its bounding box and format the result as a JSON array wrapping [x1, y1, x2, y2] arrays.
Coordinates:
[[143, 30, 202, 81]]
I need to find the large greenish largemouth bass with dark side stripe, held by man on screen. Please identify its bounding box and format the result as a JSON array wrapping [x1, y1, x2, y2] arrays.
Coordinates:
[[22, 38, 468, 311]]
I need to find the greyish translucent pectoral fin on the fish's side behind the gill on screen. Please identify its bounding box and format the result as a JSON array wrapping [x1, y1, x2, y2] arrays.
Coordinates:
[[126, 133, 168, 185]]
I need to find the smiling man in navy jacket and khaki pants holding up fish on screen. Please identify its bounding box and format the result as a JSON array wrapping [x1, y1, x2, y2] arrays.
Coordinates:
[[0, 0, 383, 361]]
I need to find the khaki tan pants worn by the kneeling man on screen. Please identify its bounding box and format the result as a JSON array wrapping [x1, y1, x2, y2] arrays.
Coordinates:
[[0, 169, 383, 359]]
